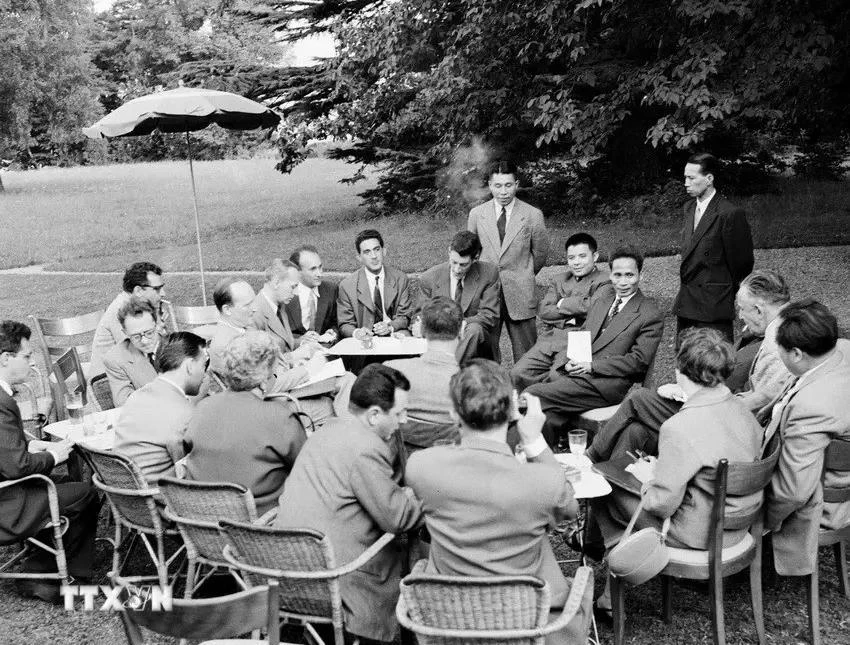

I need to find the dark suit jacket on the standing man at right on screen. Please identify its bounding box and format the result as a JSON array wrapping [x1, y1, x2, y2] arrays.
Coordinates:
[[673, 194, 754, 322]]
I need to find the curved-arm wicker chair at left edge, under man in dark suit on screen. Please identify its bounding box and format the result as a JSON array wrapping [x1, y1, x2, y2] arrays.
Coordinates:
[[0, 475, 71, 584]]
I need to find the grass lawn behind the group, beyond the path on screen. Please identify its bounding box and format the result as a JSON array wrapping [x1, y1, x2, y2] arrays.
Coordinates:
[[0, 157, 850, 271]]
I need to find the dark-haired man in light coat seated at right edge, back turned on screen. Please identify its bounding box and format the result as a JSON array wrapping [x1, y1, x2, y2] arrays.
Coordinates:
[[764, 299, 850, 576]]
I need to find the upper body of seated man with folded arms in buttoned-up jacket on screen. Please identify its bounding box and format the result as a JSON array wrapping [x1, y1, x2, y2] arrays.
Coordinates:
[[532, 233, 611, 334]]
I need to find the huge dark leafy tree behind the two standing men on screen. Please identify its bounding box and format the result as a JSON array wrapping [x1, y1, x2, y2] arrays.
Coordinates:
[[245, 0, 850, 211]]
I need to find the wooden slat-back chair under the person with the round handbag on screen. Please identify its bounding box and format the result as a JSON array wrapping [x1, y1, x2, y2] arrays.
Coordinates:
[[610, 448, 779, 645]]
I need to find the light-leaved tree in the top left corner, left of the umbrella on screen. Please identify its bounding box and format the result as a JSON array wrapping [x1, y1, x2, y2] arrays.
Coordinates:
[[0, 0, 99, 177]]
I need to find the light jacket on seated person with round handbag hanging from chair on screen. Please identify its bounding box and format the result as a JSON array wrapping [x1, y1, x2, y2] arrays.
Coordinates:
[[643, 385, 762, 549]]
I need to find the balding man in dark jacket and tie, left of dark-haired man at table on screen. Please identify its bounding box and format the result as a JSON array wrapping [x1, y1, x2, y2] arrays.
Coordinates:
[[286, 244, 338, 343]]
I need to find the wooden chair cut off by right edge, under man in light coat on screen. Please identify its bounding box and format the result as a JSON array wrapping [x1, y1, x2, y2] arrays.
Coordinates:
[[806, 439, 850, 645]]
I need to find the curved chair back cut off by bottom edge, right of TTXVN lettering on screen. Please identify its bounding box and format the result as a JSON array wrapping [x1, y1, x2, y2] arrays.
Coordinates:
[[119, 582, 280, 645]]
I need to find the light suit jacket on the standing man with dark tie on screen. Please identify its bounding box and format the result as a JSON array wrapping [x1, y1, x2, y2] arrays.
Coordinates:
[[467, 199, 549, 320]]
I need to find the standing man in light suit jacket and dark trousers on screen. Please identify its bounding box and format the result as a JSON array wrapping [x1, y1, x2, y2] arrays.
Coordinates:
[[467, 161, 549, 362]]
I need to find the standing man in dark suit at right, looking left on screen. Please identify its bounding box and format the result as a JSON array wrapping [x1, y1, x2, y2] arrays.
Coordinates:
[[673, 152, 753, 345]]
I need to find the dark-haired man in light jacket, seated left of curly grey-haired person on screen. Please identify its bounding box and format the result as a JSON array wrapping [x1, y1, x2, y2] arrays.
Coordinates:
[[114, 331, 210, 482]]
